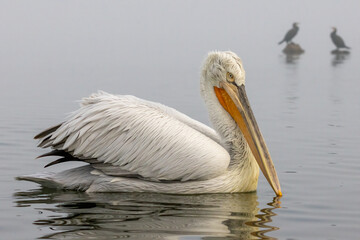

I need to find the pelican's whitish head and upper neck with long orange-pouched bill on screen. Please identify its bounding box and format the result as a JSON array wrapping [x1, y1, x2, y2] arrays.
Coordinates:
[[200, 51, 282, 196]]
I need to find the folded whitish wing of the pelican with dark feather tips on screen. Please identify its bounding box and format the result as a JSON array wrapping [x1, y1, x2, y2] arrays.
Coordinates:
[[38, 92, 230, 181]]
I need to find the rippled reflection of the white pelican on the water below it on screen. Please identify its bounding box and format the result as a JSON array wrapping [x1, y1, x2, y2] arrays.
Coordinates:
[[14, 188, 280, 239]]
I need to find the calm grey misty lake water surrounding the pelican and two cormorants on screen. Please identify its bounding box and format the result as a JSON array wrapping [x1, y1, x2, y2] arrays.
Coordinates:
[[0, 0, 360, 240]]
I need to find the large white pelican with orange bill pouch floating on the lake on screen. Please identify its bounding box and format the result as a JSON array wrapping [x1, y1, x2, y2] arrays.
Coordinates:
[[18, 51, 282, 196]]
